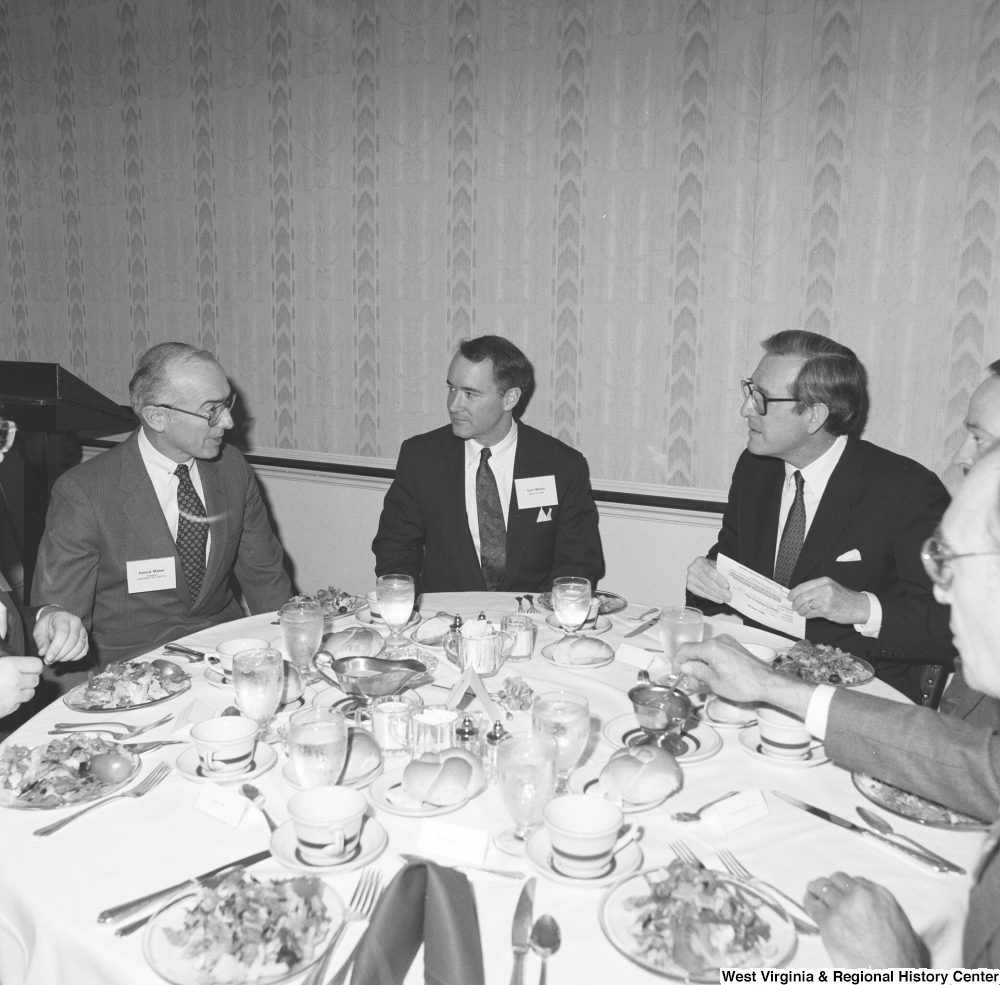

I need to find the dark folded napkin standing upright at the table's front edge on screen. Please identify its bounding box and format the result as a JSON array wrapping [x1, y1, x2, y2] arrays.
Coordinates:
[[351, 860, 485, 985]]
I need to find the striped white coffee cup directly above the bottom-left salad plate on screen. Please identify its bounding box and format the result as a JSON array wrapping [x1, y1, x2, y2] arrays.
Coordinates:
[[288, 787, 368, 865]]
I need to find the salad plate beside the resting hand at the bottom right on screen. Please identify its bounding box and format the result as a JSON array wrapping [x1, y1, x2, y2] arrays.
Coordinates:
[[598, 862, 798, 983]]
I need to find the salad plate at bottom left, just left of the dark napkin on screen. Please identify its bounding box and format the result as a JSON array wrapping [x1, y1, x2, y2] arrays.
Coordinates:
[[143, 868, 344, 985]]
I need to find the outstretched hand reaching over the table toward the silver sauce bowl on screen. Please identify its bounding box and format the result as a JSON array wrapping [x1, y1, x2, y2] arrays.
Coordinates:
[[677, 635, 813, 718]]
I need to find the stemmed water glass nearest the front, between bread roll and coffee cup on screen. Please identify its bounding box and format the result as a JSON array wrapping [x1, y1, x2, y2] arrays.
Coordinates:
[[494, 731, 558, 855]]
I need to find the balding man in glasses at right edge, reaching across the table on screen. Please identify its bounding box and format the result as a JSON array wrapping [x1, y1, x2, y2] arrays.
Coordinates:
[[681, 444, 1000, 968]]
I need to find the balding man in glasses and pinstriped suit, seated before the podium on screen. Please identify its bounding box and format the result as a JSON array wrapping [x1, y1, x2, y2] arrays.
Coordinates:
[[32, 342, 291, 683]]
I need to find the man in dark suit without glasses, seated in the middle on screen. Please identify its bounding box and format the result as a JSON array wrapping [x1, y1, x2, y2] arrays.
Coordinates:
[[372, 335, 604, 592]]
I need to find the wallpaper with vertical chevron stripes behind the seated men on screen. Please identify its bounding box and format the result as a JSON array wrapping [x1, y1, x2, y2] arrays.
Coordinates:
[[0, 0, 1000, 491]]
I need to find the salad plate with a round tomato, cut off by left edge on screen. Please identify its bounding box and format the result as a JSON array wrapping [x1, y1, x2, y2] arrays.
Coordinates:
[[0, 732, 142, 811]]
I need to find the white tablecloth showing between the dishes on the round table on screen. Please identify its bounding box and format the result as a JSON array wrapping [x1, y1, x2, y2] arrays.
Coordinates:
[[0, 593, 983, 985]]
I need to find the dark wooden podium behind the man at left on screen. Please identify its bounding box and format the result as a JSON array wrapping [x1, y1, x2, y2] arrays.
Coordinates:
[[0, 360, 139, 603]]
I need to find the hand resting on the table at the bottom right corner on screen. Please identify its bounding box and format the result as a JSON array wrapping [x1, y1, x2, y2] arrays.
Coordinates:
[[803, 872, 930, 968]]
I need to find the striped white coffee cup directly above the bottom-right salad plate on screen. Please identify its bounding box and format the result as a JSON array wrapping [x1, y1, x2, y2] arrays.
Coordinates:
[[542, 794, 638, 879]]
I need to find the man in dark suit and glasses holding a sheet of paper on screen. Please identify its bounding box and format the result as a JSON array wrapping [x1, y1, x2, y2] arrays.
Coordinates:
[[687, 331, 954, 702]]
